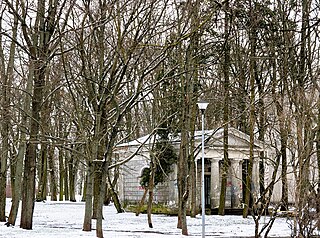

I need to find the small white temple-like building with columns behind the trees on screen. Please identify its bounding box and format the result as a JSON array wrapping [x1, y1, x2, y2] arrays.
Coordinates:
[[115, 128, 280, 209]]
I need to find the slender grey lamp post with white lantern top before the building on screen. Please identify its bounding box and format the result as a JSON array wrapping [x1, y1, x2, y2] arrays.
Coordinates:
[[197, 101, 209, 238]]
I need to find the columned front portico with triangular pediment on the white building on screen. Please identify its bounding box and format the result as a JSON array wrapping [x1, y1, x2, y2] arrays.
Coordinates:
[[197, 128, 263, 209]]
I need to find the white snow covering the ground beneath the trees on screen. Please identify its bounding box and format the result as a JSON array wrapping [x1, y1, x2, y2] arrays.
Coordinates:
[[0, 200, 291, 238]]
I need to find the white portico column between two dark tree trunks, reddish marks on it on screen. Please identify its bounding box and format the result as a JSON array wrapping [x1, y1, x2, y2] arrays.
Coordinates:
[[230, 159, 242, 208]]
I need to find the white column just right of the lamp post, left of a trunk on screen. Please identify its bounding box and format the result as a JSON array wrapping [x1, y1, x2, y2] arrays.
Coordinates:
[[210, 158, 220, 208]]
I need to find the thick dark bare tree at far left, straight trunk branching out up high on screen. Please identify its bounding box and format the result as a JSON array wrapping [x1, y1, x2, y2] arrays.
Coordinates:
[[4, 1, 74, 229]]
